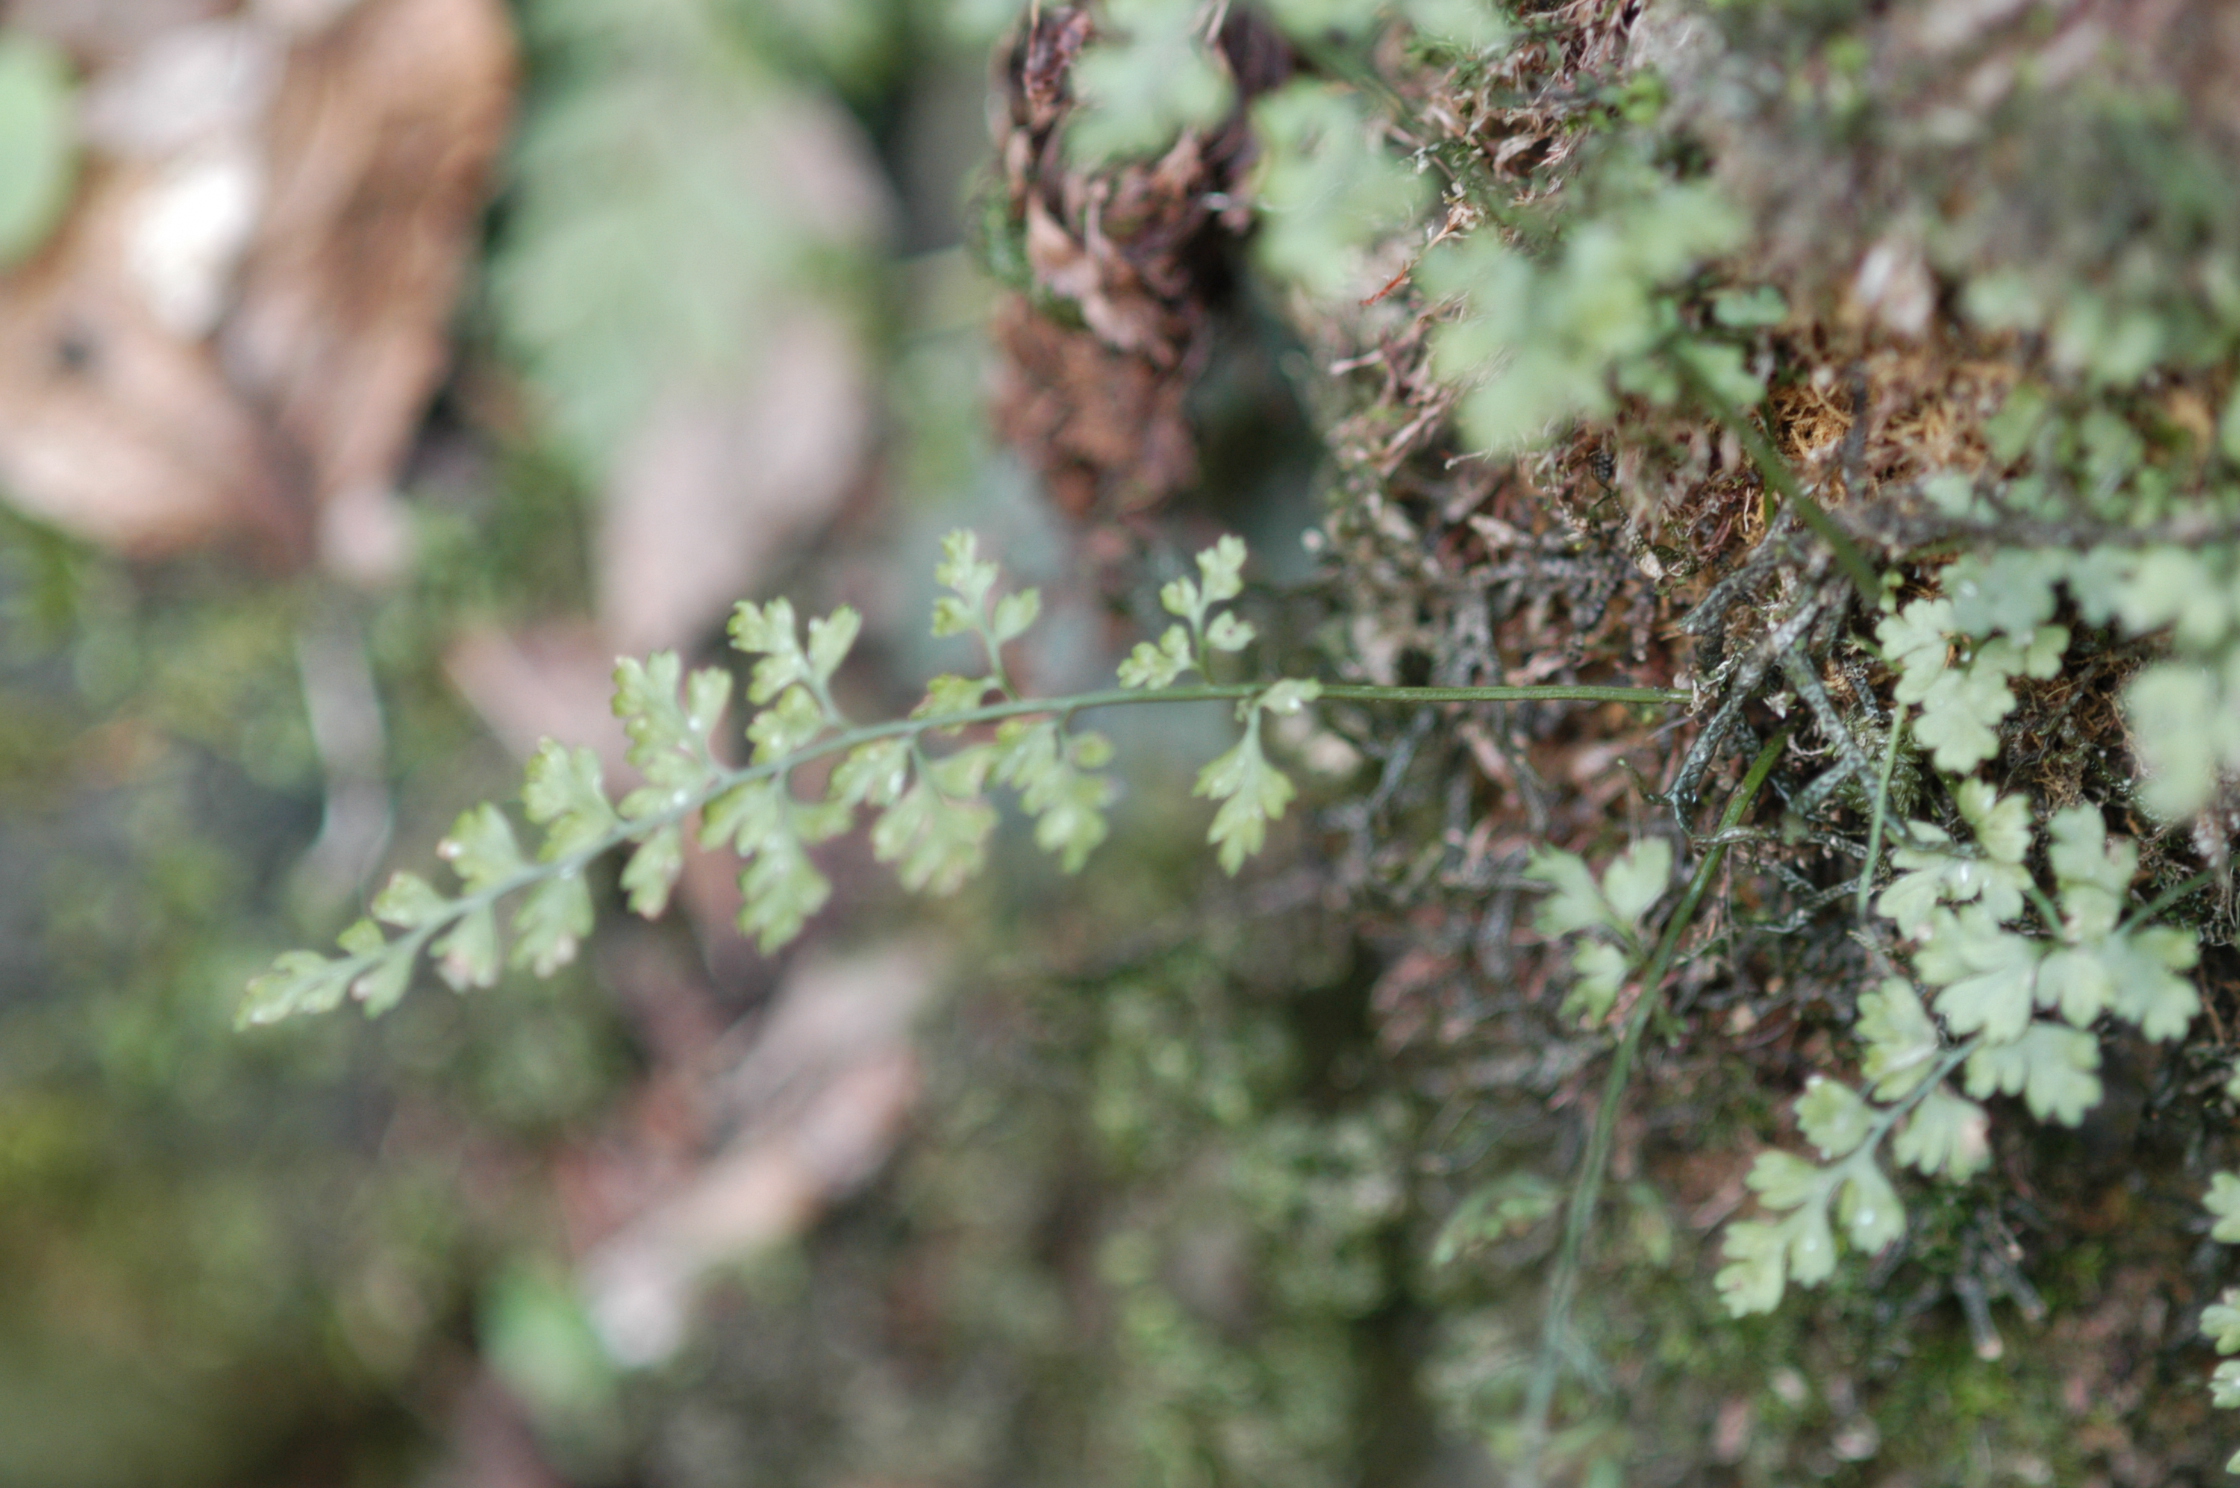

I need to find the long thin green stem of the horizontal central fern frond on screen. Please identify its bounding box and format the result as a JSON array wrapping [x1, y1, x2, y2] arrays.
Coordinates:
[[271, 681, 1689, 1012]]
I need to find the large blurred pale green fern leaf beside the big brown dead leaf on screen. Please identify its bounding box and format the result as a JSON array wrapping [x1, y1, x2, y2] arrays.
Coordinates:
[[491, 0, 880, 466]]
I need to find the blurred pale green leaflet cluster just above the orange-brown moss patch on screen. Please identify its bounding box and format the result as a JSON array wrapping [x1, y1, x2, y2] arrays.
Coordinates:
[[1418, 173, 1763, 453]]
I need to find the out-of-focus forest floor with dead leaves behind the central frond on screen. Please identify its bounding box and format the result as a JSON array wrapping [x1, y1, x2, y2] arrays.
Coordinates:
[[0, 0, 1424, 1488]]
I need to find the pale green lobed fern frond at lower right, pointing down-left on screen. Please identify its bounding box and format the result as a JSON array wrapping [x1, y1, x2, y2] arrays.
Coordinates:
[[1718, 788, 2195, 1315]]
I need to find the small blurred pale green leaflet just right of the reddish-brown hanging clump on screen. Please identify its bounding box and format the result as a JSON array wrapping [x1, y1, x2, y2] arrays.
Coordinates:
[[1252, 78, 1431, 296]]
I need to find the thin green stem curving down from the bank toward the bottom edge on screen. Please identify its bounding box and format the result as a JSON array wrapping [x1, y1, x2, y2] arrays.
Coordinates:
[[1516, 731, 1790, 1488]]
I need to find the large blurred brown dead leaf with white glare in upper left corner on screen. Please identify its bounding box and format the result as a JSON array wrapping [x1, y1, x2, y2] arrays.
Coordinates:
[[0, 0, 513, 566]]
